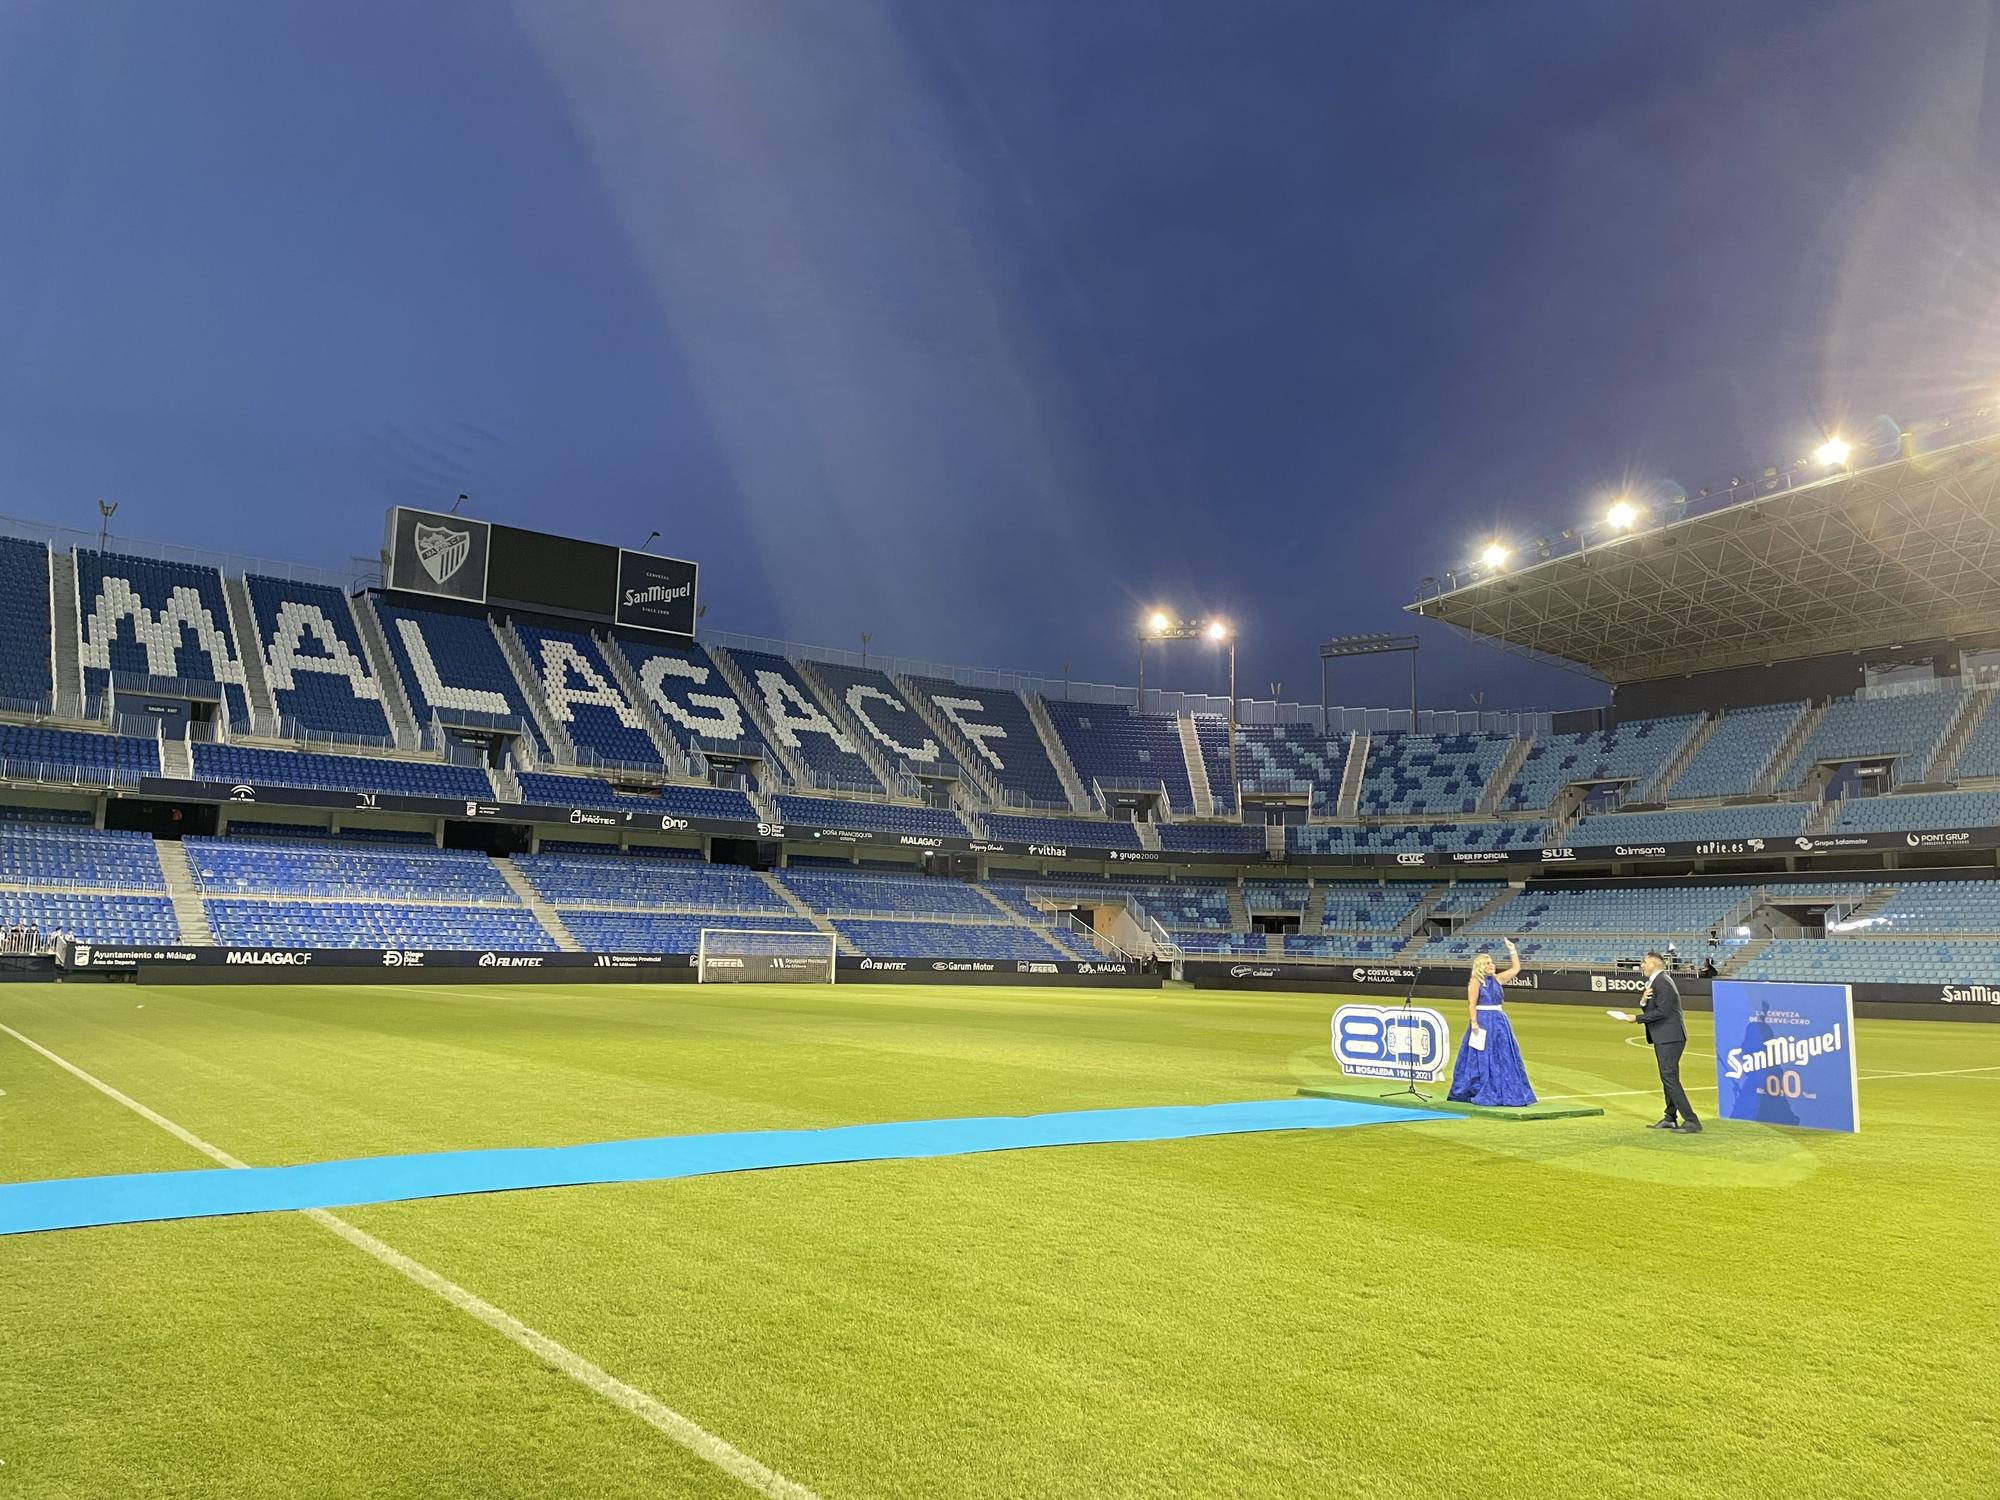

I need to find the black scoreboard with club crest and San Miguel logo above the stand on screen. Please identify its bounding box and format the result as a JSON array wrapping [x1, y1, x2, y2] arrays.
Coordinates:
[[384, 506, 700, 636]]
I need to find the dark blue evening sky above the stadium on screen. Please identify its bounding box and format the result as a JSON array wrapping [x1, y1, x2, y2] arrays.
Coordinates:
[[0, 0, 2000, 708]]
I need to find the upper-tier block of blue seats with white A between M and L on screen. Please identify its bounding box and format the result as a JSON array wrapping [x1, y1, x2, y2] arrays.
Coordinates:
[[244, 574, 390, 740]]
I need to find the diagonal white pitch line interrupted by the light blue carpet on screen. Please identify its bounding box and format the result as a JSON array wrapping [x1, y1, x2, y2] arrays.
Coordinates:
[[0, 1022, 818, 1500]]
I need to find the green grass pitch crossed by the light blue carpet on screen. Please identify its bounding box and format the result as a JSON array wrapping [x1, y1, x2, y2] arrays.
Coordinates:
[[0, 984, 2000, 1500]]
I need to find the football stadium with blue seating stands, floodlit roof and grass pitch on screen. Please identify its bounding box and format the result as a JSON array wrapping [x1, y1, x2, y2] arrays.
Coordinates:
[[0, 424, 2000, 1494]]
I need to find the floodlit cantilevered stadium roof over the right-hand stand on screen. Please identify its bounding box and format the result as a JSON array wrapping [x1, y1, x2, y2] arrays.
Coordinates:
[[1408, 438, 2000, 684]]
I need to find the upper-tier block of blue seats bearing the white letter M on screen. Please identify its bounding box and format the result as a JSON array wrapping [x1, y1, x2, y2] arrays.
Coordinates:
[[76, 548, 250, 724]]
